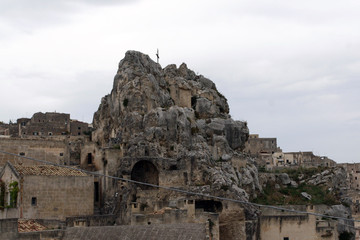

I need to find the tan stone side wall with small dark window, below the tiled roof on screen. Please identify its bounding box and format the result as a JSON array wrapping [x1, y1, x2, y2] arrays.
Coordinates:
[[20, 176, 94, 220]]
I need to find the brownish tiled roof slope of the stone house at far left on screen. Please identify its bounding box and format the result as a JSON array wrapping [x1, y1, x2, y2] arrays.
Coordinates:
[[13, 165, 88, 176]]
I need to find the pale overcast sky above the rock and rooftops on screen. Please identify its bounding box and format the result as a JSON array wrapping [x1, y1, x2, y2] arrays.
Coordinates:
[[0, 0, 360, 162]]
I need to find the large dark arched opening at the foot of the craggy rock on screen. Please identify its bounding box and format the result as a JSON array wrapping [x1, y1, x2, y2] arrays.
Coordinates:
[[131, 160, 159, 190]]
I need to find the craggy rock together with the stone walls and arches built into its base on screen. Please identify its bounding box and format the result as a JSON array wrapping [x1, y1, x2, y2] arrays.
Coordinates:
[[87, 51, 261, 239]]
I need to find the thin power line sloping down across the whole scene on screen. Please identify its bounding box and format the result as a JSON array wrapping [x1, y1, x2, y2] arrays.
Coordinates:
[[0, 150, 360, 226]]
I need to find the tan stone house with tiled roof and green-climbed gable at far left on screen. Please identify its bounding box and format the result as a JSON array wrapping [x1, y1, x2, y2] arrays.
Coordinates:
[[0, 162, 94, 220]]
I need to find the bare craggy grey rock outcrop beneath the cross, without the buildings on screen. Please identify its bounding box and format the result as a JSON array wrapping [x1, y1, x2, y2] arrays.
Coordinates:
[[92, 51, 261, 237]]
